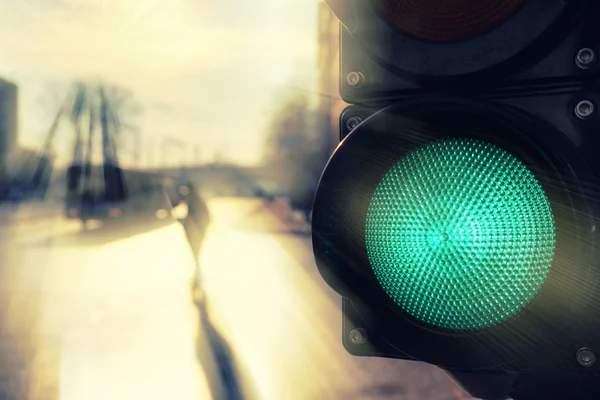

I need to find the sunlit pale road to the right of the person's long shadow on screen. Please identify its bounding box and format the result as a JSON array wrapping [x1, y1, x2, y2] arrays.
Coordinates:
[[200, 198, 472, 400]]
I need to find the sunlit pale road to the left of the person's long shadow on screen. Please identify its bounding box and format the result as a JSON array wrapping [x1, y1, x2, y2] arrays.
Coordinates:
[[0, 205, 211, 400]]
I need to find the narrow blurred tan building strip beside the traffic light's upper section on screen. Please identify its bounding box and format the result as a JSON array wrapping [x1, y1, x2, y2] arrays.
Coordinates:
[[317, 2, 347, 151]]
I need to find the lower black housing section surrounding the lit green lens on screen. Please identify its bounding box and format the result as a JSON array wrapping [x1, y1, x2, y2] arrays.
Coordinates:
[[313, 90, 600, 373]]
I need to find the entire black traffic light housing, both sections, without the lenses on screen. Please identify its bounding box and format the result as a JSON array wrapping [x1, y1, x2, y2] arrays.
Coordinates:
[[312, 0, 600, 400]]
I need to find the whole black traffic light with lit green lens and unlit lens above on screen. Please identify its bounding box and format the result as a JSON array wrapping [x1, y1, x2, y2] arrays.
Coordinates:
[[312, 0, 600, 400]]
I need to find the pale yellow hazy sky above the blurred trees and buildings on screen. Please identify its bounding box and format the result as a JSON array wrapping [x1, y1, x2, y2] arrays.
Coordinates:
[[0, 0, 318, 164]]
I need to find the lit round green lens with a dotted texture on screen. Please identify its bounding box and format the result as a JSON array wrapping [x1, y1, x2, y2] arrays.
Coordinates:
[[366, 138, 555, 331]]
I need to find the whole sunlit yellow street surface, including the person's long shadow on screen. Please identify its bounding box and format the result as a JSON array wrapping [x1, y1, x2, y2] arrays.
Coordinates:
[[0, 197, 468, 400]]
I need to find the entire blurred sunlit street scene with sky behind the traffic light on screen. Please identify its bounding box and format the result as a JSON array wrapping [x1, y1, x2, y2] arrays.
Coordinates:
[[0, 0, 474, 400]]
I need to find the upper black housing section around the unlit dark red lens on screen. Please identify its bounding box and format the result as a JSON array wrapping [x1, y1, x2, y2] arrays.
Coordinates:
[[338, 0, 600, 105]]
